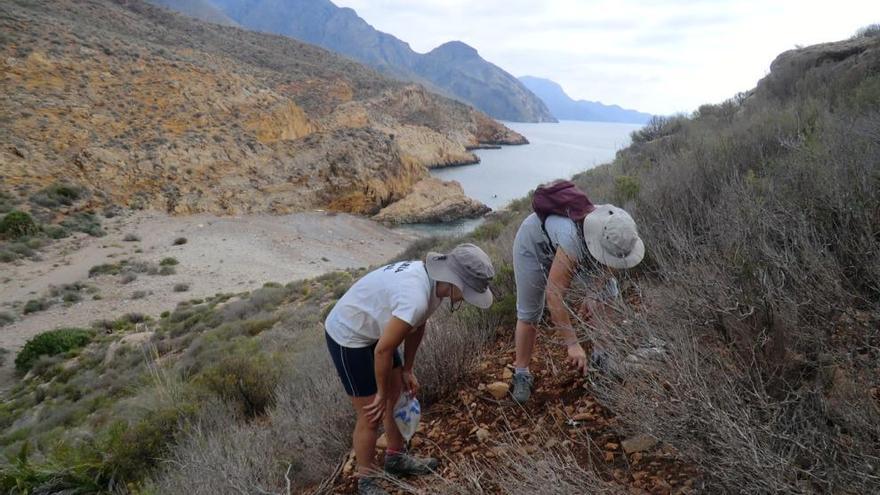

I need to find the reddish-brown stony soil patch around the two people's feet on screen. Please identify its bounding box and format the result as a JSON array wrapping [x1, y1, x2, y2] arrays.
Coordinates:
[[332, 333, 699, 495]]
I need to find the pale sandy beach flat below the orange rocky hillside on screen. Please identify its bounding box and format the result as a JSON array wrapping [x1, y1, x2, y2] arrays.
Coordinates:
[[0, 212, 415, 391]]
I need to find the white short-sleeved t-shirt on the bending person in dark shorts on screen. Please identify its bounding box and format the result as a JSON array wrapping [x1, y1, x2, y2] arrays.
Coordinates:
[[324, 261, 440, 348]]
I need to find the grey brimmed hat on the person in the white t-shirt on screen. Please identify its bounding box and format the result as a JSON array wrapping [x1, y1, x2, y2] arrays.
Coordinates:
[[425, 244, 495, 309]]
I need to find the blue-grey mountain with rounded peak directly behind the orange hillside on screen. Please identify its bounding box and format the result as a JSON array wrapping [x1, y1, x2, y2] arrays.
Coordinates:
[[162, 0, 556, 122]]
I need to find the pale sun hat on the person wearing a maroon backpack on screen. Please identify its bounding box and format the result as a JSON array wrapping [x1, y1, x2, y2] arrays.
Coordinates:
[[584, 205, 645, 268]]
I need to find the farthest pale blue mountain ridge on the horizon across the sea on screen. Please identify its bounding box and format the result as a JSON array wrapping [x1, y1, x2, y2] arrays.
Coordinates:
[[519, 76, 651, 124]]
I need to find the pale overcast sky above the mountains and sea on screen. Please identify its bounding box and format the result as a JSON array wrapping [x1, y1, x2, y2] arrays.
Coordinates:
[[332, 0, 880, 114]]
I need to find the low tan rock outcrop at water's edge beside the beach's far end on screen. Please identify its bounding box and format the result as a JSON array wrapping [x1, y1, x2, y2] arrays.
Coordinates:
[[373, 177, 489, 224]]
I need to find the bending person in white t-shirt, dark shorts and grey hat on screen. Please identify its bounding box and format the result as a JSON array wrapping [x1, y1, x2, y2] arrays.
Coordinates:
[[324, 244, 495, 495]]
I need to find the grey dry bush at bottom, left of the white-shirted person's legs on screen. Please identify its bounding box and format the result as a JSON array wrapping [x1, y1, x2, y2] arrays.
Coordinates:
[[152, 353, 354, 495]]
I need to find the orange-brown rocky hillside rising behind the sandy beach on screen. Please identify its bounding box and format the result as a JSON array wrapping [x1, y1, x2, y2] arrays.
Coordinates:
[[0, 0, 525, 214]]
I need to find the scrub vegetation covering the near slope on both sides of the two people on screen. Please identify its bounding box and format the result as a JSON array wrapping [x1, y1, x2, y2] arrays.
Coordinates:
[[0, 33, 880, 494]]
